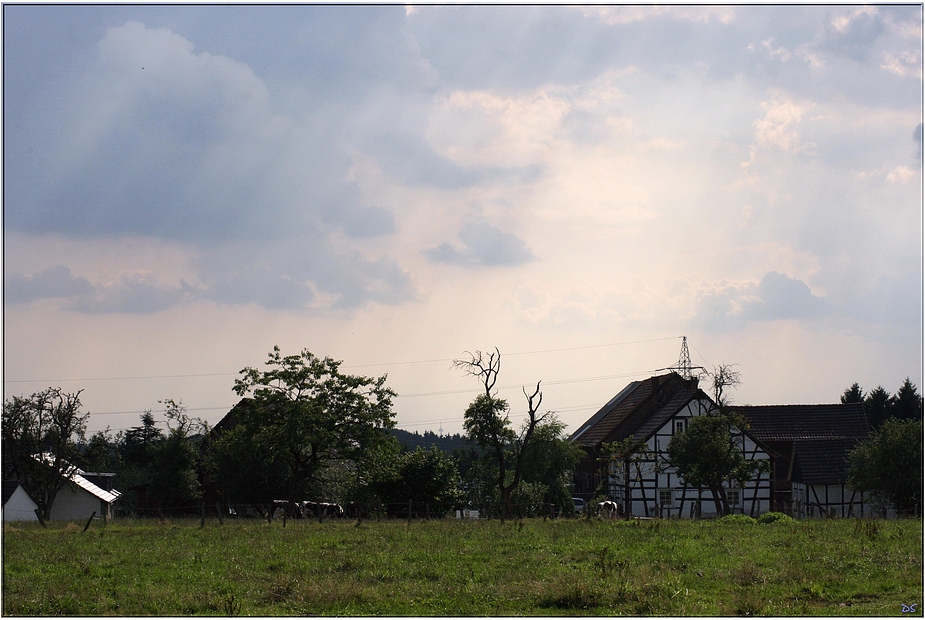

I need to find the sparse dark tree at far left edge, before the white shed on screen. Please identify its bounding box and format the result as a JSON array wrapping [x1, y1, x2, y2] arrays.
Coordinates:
[[2, 388, 89, 519]]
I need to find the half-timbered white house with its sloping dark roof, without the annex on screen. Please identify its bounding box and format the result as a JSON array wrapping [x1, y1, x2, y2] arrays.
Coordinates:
[[570, 373, 772, 517]]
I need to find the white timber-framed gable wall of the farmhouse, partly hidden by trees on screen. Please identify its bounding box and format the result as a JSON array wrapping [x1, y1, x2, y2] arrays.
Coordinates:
[[608, 401, 771, 518]]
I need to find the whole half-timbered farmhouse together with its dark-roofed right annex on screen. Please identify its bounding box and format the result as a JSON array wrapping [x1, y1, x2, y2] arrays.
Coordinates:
[[569, 372, 870, 517]]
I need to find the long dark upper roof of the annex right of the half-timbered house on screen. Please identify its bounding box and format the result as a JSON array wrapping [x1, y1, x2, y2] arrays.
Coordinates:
[[731, 403, 868, 441]]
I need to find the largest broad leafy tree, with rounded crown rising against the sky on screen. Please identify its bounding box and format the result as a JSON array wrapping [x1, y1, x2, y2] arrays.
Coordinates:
[[222, 347, 395, 501]]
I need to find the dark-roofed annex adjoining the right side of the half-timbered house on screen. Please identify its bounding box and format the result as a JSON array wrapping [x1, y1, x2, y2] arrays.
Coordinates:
[[735, 403, 869, 517]]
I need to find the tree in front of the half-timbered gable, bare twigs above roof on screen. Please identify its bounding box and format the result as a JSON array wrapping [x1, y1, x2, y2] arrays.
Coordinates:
[[668, 366, 767, 516]]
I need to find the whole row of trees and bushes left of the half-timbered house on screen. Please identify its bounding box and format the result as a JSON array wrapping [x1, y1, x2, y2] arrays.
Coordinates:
[[2, 347, 582, 518]]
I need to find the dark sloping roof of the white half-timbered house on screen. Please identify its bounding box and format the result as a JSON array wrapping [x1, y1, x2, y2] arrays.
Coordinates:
[[569, 372, 707, 448]]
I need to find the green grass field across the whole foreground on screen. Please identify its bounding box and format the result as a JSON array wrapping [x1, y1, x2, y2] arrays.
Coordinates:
[[3, 520, 923, 616]]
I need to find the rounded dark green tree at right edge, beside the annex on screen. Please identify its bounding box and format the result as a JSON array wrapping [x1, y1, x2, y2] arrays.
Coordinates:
[[848, 418, 922, 514]]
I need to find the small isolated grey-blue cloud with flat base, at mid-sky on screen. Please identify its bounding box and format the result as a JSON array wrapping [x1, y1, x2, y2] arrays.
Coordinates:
[[424, 219, 535, 267]]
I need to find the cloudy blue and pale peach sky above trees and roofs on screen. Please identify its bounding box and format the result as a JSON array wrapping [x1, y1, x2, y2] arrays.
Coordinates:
[[3, 4, 923, 440]]
